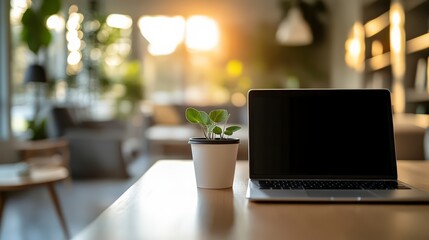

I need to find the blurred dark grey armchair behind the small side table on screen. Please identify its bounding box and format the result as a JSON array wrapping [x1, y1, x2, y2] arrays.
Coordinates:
[[47, 106, 135, 178]]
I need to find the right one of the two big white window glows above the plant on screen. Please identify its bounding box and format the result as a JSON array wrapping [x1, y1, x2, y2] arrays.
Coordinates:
[[186, 16, 219, 51]]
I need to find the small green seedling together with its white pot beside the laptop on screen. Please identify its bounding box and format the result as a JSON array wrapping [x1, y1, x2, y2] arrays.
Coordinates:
[[185, 108, 241, 189]]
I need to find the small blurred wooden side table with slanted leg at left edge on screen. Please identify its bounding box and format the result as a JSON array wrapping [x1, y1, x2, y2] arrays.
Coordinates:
[[0, 166, 70, 239]]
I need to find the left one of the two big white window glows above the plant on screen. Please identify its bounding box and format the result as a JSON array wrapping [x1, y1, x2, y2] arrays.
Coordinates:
[[138, 16, 185, 55]]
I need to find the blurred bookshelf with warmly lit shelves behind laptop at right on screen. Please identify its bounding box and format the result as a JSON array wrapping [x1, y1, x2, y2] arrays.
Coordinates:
[[363, 0, 429, 114]]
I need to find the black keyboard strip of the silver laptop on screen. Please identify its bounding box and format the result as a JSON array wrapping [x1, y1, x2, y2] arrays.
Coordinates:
[[259, 180, 409, 190]]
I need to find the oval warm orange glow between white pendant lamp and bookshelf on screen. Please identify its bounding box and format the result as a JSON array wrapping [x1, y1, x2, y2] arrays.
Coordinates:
[[345, 22, 365, 72]]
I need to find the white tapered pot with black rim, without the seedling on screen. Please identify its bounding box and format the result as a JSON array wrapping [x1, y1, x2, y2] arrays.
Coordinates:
[[189, 138, 240, 189]]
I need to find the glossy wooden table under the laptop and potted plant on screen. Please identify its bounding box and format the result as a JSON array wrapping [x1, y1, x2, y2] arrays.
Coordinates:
[[74, 160, 429, 240]]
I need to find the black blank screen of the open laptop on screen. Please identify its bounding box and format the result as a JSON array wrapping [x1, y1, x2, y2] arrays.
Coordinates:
[[248, 89, 397, 179]]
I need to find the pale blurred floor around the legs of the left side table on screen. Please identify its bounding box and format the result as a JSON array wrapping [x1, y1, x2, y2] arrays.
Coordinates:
[[0, 153, 157, 240]]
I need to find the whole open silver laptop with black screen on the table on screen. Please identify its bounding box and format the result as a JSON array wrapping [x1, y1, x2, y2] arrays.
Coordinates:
[[246, 89, 429, 202]]
